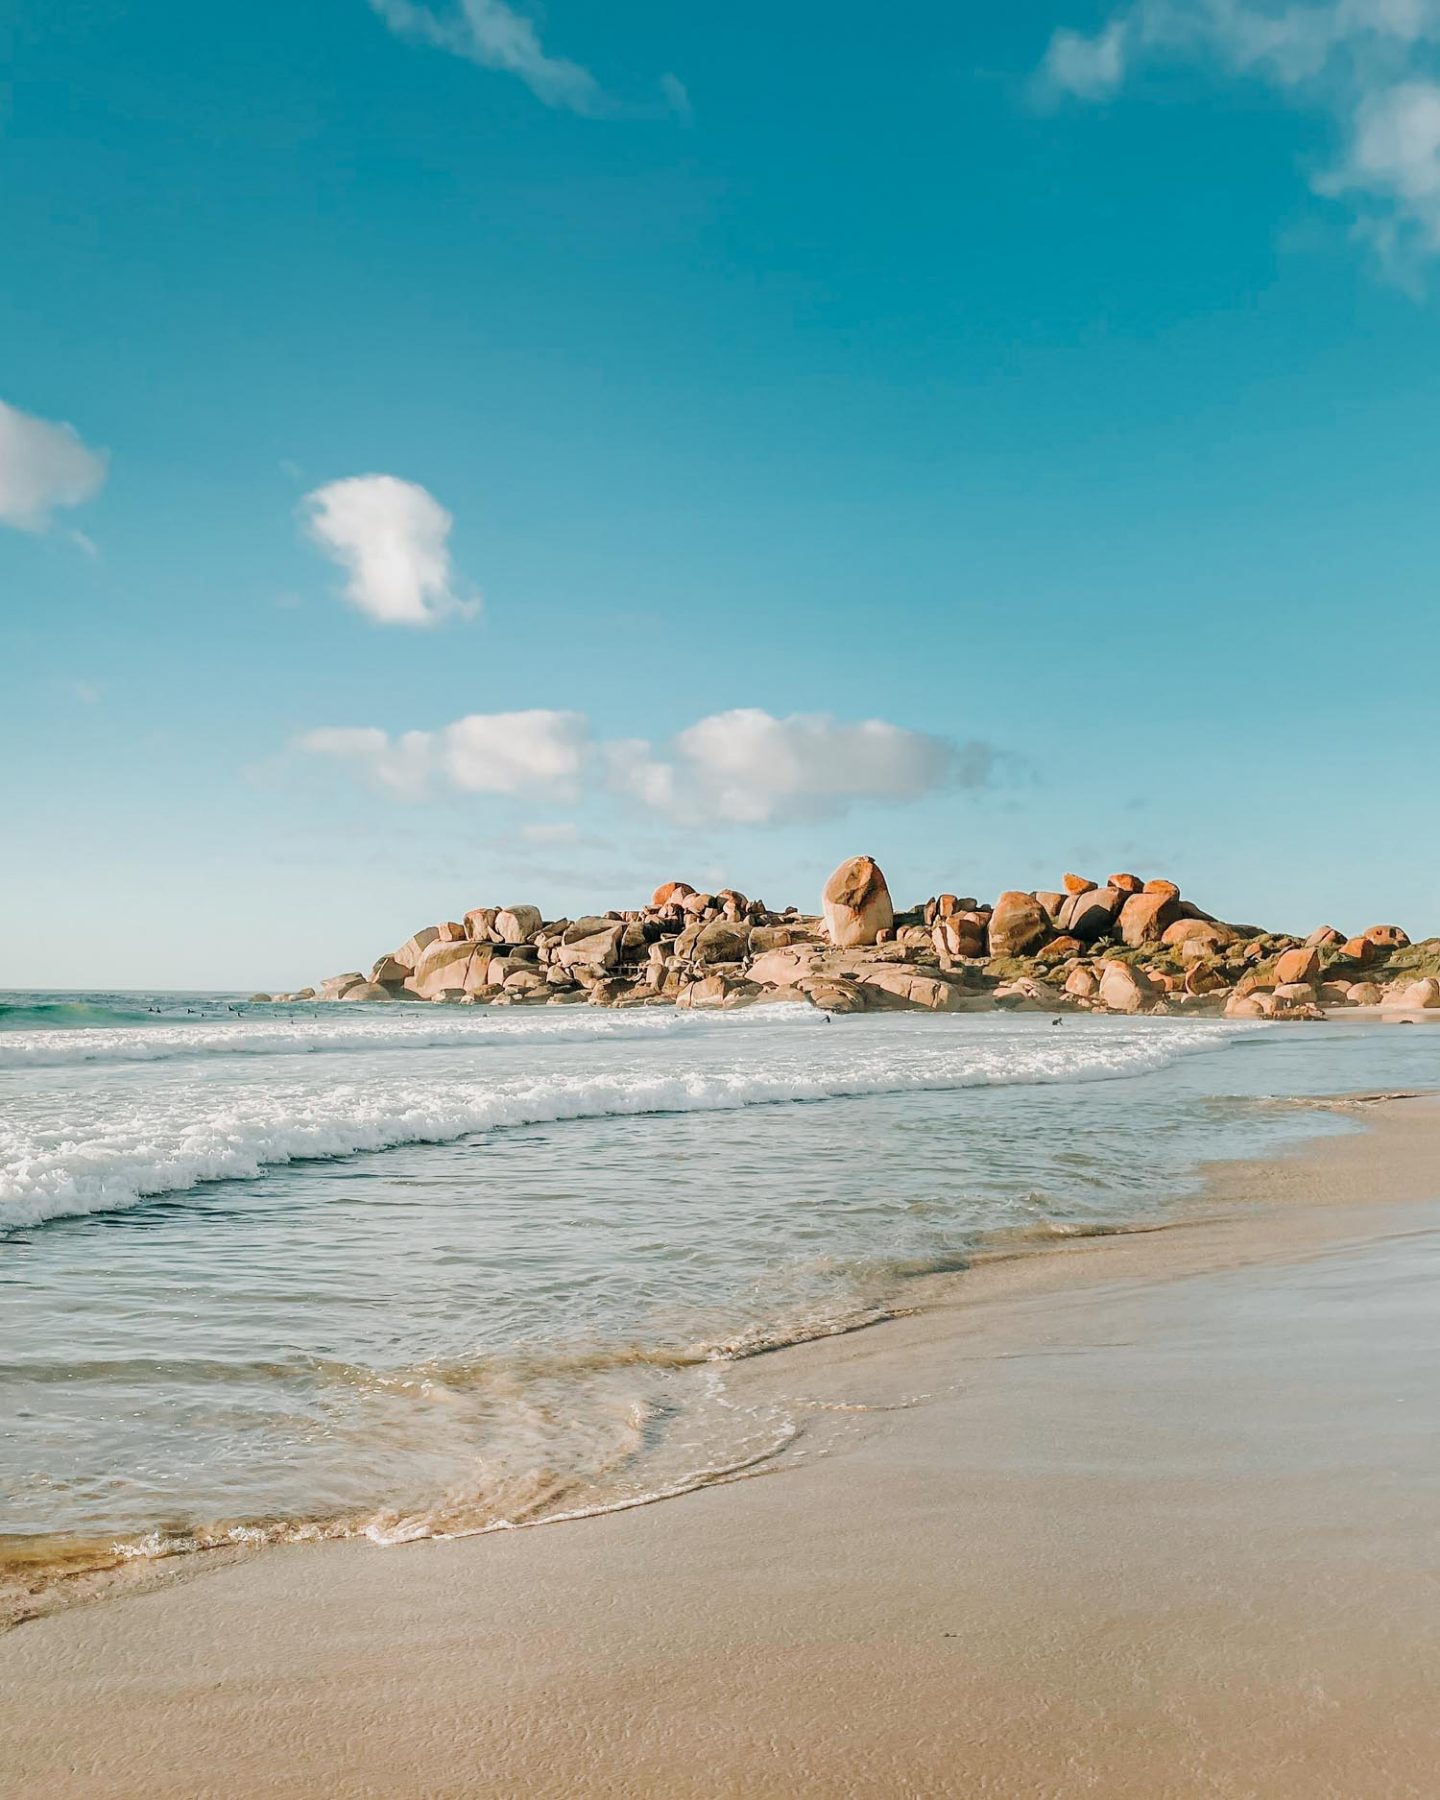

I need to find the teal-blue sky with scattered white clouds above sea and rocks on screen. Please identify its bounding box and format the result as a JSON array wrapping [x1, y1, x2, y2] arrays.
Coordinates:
[[0, 0, 1440, 988]]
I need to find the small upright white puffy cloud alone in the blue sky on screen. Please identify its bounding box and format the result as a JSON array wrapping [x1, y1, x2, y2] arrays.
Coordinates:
[[301, 475, 479, 625]]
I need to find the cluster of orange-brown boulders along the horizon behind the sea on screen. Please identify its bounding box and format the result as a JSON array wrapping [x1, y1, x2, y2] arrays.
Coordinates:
[[256, 857, 1440, 1019]]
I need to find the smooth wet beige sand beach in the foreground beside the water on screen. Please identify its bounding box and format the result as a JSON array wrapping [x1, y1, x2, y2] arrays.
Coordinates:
[[0, 1100, 1440, 1800]]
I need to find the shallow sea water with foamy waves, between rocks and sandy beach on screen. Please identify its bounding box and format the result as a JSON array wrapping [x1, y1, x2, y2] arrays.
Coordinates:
[[0, 995, 1440, 1605]]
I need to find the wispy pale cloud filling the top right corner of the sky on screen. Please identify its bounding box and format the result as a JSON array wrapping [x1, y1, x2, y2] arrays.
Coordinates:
[[1039, 0, 1440, 283]]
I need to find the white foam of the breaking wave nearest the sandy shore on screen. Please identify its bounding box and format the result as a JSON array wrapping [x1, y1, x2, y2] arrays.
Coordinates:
[[0, 1021, 1228, 1226]]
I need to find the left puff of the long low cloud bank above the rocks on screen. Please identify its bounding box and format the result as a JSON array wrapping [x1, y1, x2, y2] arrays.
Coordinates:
[[295, 709, 590, 799]]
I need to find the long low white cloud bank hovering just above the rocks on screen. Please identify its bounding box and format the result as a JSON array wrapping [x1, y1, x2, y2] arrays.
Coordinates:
[[297, 707, 995, 824]]
